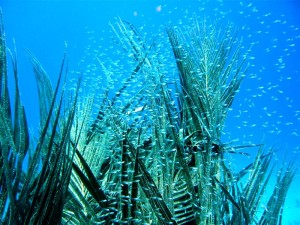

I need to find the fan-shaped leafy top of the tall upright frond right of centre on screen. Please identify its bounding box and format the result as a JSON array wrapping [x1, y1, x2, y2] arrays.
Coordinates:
[[167, 19, 246, 140]]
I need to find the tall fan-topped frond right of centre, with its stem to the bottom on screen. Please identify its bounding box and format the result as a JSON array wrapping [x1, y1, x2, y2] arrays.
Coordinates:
[[167, 19, 245, 224]]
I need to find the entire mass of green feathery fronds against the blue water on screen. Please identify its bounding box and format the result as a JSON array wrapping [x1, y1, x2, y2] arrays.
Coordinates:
[[0, 9, 295, 225]]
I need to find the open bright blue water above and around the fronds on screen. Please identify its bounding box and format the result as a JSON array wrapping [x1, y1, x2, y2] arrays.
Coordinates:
[[0, 0, 300, 224]]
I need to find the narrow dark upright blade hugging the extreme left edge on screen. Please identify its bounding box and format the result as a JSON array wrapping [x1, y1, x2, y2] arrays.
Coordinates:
[[0, 9, 17, 222]]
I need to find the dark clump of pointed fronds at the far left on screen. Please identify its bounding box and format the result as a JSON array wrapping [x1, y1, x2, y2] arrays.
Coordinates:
[[0, 8, 78, 224]]
